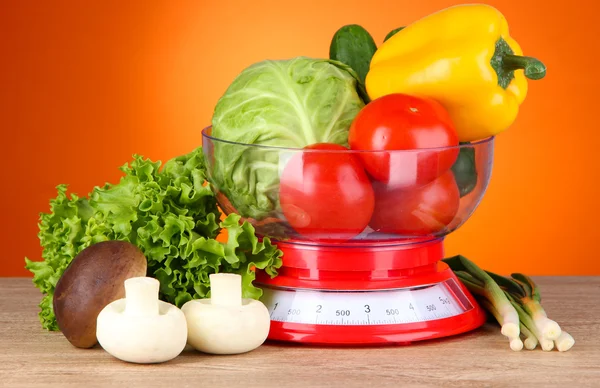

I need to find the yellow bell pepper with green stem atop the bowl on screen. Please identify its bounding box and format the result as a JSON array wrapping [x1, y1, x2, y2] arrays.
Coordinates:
[[365, 4, 546, 142]]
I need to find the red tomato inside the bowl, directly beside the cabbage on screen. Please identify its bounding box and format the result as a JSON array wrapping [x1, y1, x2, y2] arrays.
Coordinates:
[[279, 144, 375, 241]]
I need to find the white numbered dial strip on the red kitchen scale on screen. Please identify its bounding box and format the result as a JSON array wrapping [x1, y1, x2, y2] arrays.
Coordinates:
[[262, 279, 473, 326]]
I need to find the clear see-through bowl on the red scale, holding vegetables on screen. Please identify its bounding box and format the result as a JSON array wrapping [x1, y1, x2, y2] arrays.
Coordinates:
[[202, 127, 494, 244]]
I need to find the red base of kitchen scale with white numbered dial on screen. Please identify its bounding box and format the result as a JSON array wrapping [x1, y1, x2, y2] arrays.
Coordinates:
[[257, 240, 486, 346]]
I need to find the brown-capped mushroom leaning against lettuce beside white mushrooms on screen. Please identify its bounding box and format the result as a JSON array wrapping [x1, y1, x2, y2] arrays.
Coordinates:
[[53, 241, 147, 348]]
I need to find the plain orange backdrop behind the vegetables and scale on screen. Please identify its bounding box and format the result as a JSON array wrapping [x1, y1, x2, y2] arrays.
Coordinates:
[[0, 0, 600, 276]]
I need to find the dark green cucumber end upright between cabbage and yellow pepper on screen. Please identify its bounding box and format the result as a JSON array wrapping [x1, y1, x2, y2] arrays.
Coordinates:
[[329, 24, 377, 102]]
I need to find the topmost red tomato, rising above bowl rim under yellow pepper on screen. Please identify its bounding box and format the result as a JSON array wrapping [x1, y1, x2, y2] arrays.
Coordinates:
[[348, 94, 458, 188]]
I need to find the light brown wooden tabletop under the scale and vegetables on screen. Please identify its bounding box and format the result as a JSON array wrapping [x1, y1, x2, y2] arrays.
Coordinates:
[[0, 277, 600, 388]]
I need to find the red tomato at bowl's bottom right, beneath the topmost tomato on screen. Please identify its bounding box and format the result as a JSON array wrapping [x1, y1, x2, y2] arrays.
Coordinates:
[[369, 171, 460, 237]]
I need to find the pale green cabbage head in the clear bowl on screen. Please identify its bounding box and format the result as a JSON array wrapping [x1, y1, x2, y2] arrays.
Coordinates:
[[210, 57, 364, 220]]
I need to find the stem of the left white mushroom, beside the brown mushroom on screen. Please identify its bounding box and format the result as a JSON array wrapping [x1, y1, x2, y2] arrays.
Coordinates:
[[125, 277, 160, 316]]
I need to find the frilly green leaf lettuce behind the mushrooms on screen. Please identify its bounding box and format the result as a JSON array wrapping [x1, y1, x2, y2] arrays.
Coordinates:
[[26, 148, 282, 330]]
